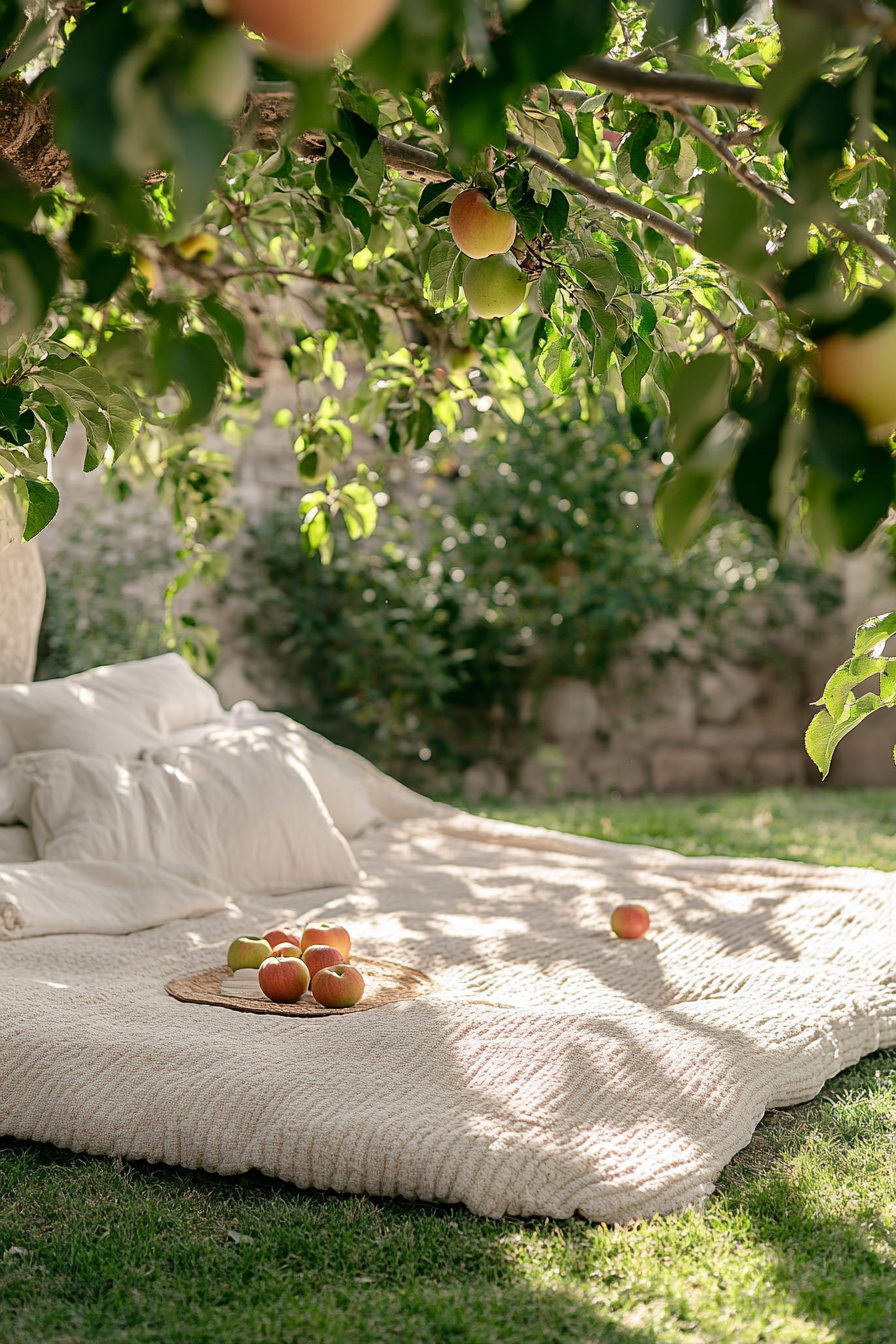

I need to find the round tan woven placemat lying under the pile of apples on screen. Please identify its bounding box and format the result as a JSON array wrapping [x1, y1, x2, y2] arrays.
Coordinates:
[[165, 957, 435, 1017]]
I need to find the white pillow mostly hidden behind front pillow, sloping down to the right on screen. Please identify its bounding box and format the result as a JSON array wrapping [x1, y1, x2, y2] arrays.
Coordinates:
[[163, 700, 441, 840]]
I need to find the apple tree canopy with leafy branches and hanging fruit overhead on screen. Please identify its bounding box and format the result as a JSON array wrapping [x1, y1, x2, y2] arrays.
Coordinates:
[[0, 0, 896, 720]]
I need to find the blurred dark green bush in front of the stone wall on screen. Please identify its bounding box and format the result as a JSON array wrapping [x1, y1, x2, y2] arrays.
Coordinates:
[[246, 415, 837, 780]]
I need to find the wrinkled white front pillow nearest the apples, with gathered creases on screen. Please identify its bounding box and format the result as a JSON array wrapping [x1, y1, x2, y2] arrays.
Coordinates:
[[12, 728, 359, 895]]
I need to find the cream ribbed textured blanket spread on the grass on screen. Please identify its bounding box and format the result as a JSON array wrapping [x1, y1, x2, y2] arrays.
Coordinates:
[[0, 814, 896, 1220]]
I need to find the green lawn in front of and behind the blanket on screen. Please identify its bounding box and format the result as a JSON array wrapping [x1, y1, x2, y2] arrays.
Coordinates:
[[0, 790, 896, 1344]]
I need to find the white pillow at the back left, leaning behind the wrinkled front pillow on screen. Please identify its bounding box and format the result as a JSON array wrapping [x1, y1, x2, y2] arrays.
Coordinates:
[[0, 653, 224, 766]]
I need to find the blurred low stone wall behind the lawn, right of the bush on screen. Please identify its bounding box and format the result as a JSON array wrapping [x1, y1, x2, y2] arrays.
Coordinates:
[[463, 551, 896, 802]]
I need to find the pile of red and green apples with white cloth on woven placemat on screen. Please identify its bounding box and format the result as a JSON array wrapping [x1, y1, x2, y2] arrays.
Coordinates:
[[222, 923, 364, 1008]]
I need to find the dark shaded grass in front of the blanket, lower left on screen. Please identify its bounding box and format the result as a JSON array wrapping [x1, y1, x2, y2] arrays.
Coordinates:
[[0, 1140, 656, 1344]]
